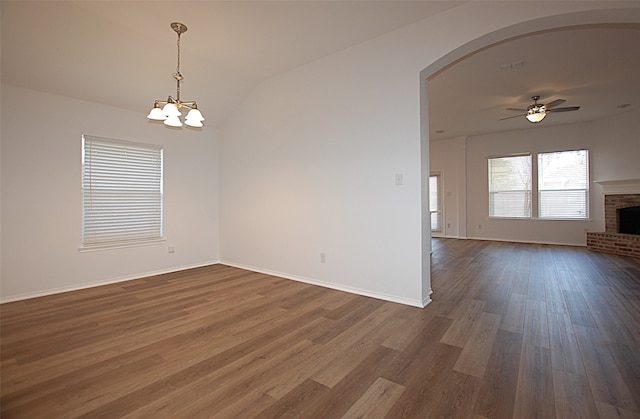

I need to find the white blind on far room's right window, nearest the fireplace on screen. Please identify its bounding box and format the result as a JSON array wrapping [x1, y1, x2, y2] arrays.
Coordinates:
[[538, 150, 589, 218]]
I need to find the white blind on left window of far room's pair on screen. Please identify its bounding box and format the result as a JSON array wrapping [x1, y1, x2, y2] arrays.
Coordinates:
[[489, 154, 531, 218]]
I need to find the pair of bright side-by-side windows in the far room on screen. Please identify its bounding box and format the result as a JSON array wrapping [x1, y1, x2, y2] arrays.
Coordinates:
[[489, 150, 589, 219]]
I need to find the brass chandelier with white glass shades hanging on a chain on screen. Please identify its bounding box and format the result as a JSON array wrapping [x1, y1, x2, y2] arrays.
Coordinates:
[[147, 22, 204, 128]]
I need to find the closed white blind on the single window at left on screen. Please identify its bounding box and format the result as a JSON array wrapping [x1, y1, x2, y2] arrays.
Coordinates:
[[82, 135, 163, 248]]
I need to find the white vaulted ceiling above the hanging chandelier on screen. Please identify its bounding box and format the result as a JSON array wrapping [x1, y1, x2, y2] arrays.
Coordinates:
[[0, 0, 461, 126]]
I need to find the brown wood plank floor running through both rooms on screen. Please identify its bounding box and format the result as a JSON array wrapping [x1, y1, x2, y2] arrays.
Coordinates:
[[0, 239, 640, 419]]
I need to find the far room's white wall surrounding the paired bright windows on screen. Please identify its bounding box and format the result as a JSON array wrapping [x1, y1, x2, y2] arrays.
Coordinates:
[[430, 111, 640, 246]]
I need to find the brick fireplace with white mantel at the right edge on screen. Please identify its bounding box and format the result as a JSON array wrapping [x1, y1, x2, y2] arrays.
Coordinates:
[[587, 180, 640, 258]]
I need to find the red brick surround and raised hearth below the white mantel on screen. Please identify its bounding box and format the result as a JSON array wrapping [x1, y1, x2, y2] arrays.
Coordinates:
[[587, 184, 640, 258]]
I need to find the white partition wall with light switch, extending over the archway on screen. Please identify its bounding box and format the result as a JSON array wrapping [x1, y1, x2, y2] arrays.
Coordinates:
[[220, 2, 640, 305]]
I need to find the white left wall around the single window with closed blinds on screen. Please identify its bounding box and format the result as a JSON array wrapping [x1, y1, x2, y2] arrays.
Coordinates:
[[0, 85, 218, 302]]
